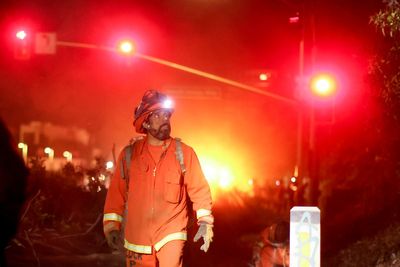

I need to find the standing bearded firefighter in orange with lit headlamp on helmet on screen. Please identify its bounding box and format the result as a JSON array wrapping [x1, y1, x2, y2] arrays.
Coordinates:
[[103, 90, 214, 267]]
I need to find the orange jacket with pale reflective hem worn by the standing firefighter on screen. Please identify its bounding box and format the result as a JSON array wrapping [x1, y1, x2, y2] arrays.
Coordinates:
[[103, 139, 212, 254]]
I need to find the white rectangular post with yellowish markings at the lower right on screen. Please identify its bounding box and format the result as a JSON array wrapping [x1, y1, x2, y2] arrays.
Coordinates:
[[290, 207, 321, 267]]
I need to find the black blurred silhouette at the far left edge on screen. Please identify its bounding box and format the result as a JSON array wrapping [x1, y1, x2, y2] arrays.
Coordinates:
[[0, 118, 28, 267]]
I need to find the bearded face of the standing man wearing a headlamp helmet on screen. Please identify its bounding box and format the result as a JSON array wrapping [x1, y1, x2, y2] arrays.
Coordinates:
[[147, 109, 171, 140]]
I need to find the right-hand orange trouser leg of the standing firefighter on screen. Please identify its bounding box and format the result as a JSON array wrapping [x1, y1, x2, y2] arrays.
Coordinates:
[[156, 240, 186, 267]]
